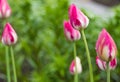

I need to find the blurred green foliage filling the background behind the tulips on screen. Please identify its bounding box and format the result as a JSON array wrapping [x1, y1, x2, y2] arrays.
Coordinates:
[[0, 0, 120, 82]]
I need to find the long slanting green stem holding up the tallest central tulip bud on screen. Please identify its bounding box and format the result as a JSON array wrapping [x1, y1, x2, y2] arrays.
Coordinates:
[[81, 29, 94, 82]]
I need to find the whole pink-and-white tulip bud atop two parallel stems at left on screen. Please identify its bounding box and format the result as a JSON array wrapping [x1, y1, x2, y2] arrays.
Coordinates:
[[2, 23, 17, 45]]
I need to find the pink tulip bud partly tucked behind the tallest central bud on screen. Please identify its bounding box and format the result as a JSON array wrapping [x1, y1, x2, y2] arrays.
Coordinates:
[[64, 21, 81, 41]]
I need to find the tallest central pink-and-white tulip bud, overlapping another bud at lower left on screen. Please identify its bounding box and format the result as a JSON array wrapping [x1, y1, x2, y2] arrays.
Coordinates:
[[69, 4, 89, 30]]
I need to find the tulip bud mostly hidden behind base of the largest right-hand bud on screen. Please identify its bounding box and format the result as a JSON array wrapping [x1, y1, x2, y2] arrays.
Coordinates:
[[96, 56, 117, 70]]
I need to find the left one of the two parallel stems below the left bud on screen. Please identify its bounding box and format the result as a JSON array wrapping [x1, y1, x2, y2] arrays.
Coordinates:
[[6, 46, 11, 82]]
